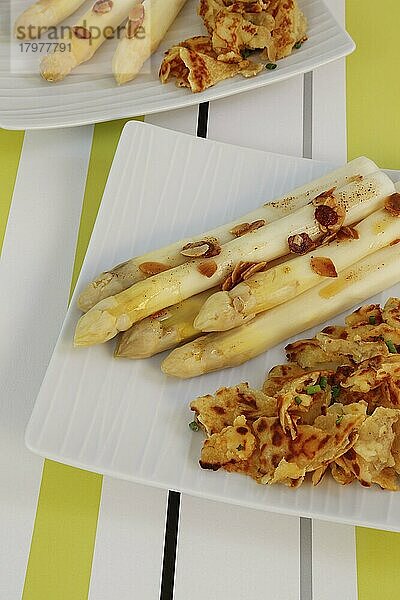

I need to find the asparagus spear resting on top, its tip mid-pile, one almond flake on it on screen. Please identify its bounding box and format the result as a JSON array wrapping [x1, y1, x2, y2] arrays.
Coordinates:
[[194, 208, 400, 331]]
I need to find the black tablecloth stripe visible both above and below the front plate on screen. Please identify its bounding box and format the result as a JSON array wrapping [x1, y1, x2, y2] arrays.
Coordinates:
[[160, 102, 209, 600]]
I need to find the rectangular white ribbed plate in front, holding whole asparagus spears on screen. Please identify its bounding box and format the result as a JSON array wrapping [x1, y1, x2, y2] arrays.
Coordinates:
[[26, 122, 400, 530]]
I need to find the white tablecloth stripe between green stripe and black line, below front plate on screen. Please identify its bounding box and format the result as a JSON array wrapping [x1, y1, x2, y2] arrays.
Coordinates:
[[89, 477, 167, 600]]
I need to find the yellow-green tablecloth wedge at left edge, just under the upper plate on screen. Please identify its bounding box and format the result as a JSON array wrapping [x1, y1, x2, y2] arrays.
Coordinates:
[[0, 129, 24, 253]]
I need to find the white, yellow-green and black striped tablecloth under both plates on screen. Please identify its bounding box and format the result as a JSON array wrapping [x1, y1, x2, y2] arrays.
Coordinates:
[[0, 0, 400, 600]]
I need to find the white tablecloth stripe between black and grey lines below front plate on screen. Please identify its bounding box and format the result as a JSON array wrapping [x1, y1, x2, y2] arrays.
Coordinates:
[[174, 494, 299, 600]]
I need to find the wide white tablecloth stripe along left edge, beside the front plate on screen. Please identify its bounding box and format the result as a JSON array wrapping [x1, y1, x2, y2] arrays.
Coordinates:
[[0, 127, 92, 600]]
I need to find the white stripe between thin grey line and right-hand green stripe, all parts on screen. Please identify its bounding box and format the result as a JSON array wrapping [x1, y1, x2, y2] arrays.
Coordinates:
[[313, 0, 357, 600]]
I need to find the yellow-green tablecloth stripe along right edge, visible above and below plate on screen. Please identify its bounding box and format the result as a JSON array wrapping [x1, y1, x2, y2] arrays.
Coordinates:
[[346, 0, 400, 600]]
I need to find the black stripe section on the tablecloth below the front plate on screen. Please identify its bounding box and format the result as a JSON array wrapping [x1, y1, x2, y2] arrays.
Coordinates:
[[160, 492, 181, 600]]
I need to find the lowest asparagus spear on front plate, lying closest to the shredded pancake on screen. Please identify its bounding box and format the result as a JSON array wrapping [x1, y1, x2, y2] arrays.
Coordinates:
[[161, 244, 400, 379]]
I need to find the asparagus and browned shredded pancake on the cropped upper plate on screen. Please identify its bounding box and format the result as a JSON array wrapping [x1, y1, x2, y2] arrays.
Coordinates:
[[14, 0, 307, 85]]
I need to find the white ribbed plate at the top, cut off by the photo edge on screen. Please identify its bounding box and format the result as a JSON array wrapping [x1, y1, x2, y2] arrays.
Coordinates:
[[0, 0, 355, 129]]
